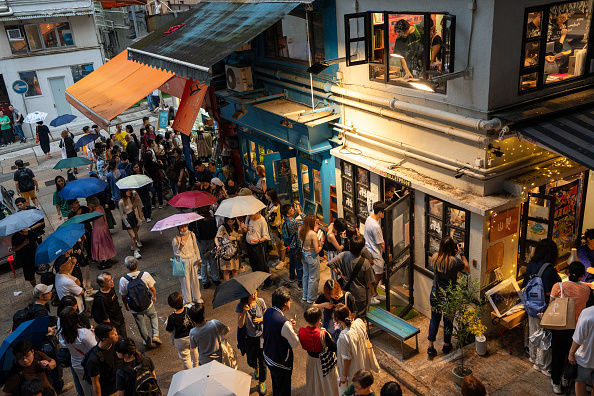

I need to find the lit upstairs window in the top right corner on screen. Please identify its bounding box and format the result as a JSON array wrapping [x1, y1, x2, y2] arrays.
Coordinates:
[[519, 0, 594, 92]]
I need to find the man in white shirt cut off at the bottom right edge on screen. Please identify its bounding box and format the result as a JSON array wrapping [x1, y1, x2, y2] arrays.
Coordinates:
[[568, 307, 594, 396]]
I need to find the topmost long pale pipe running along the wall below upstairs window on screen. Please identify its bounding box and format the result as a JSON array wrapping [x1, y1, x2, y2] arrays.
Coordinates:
[[254, 66, 503, 135]]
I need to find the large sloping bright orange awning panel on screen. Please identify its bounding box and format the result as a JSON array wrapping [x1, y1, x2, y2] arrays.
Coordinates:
[[66, 50, 174, 129]]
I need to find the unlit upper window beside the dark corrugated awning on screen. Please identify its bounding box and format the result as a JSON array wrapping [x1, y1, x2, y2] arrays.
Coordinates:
[[264, 10, 325, 62]]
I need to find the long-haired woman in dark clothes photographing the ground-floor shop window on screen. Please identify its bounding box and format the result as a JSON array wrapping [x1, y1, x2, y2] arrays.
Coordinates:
[[427, 236, 468, 356]]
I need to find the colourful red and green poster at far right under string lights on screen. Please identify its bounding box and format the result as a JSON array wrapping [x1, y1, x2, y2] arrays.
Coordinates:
[[549, 179, 580, 245]]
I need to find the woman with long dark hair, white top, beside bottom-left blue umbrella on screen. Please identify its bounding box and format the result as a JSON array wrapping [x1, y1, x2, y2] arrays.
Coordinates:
[[58, 307, 97, 396]]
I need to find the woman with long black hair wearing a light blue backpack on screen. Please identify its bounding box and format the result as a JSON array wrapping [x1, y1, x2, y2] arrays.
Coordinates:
[[524, 238, 561, 377]]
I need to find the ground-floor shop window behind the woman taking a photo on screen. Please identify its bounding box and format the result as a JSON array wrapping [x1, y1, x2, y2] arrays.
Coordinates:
[[425, 196, 470, 272]]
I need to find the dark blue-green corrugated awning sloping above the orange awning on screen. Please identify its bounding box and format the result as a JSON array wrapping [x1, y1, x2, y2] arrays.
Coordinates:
[[128, 0, 313, 81]]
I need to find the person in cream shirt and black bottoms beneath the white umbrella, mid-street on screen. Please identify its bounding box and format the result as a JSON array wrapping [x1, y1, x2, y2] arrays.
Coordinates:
[[241, 213, 272, 290]]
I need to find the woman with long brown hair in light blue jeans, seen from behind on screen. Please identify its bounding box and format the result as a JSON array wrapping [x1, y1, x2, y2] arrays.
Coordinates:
[[297, 214, 322, 304]]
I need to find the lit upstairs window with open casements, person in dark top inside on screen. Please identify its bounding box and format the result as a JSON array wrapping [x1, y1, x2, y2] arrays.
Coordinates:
[[345, 12, 456, 91]]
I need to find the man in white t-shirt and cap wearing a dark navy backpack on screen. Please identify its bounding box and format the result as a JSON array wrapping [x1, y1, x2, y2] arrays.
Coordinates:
[[120, 256, 162, 348]]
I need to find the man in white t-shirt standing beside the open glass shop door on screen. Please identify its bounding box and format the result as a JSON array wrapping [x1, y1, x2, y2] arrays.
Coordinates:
[[363, 201, 388, 305]]
